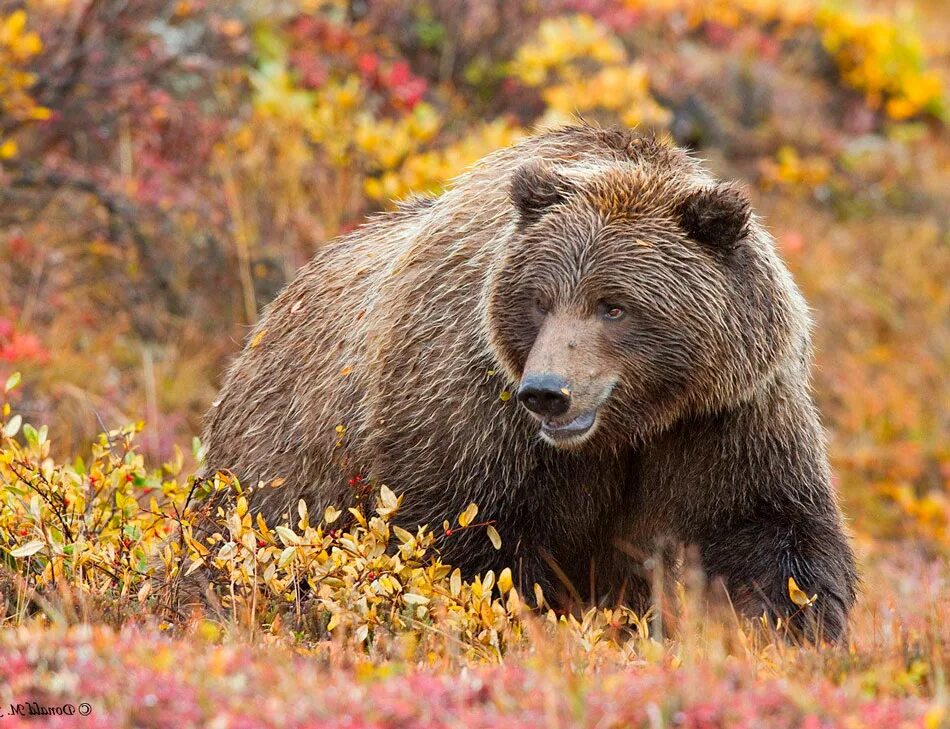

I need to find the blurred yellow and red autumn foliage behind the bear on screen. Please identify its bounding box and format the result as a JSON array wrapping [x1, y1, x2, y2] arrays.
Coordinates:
[[0, 0, 950, 550]]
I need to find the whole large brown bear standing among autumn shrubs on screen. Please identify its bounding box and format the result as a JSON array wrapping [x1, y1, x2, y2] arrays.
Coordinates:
[[205, 125, 856, 638]]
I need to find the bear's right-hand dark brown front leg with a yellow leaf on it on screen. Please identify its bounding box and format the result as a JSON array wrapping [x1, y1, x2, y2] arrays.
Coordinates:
[[642, 373, 857, 640]]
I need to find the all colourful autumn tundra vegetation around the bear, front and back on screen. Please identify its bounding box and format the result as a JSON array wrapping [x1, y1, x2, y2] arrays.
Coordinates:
[[0, 0, 950, 729]]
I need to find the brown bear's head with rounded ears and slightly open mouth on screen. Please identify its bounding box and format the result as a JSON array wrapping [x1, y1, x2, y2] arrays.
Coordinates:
[[486, 155, 808, 447]]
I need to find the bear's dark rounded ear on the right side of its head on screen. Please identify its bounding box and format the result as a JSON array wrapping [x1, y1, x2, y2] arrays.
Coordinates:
[[677, 182, 752, 250]]
